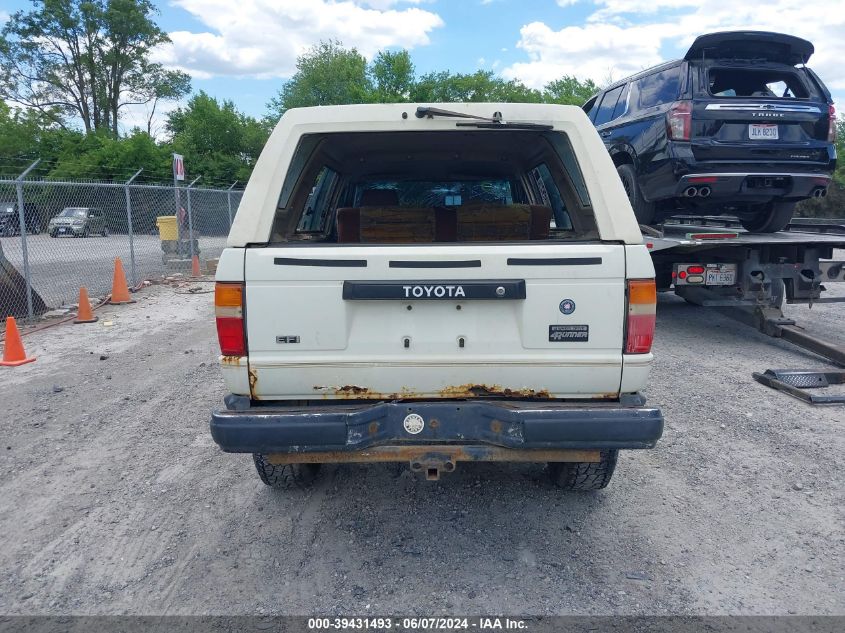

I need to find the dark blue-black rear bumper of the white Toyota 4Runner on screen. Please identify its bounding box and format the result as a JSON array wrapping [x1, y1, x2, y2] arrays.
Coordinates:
[[211, 399, 663, 454]]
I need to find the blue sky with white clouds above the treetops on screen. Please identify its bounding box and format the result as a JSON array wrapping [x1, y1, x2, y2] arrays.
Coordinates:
[[0, 0, 845, 129]]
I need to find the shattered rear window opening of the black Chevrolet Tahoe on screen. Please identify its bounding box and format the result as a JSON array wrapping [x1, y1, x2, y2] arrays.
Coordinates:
[[708, 68, 810, 99]]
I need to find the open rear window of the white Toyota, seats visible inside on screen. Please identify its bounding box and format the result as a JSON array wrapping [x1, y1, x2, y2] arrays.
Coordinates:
[[270, 130, 597, 244]]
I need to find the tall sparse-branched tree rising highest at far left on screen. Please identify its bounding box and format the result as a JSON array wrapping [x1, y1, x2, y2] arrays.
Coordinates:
[[0, 0, 189, 136]]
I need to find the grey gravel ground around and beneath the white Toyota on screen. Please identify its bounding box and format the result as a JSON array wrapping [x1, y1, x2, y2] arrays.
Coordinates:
[[0, 278, 845, 615]]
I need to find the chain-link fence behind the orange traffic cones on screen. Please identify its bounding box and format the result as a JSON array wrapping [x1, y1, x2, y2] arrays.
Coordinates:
[[0, 165, 243, 319]]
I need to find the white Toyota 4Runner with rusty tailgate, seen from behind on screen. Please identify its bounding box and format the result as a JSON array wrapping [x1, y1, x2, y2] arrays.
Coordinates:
[[211, 103, 663, 490]]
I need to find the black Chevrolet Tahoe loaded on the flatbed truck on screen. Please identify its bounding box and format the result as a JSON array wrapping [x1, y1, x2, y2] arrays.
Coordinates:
[[584, 31, 836, 233]]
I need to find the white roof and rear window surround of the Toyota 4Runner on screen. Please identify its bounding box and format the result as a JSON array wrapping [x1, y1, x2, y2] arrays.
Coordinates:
[[227, 103, 642, 247]]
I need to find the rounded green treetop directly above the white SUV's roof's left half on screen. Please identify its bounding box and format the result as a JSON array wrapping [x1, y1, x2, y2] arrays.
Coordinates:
[[268, 41, 373, 119]]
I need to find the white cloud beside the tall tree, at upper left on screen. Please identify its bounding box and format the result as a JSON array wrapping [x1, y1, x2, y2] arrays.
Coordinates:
[[156, 0, 443, 78]]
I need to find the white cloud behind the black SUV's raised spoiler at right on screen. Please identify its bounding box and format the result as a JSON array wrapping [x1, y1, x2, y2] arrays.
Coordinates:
[[502, 0, 845, 103]]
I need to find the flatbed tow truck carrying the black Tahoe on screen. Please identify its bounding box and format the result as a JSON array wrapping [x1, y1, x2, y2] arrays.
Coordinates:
[[641, 216, 845, 404]]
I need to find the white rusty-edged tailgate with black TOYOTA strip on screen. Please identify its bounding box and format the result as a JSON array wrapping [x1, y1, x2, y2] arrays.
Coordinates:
[[245, 243, 625, 400]]
